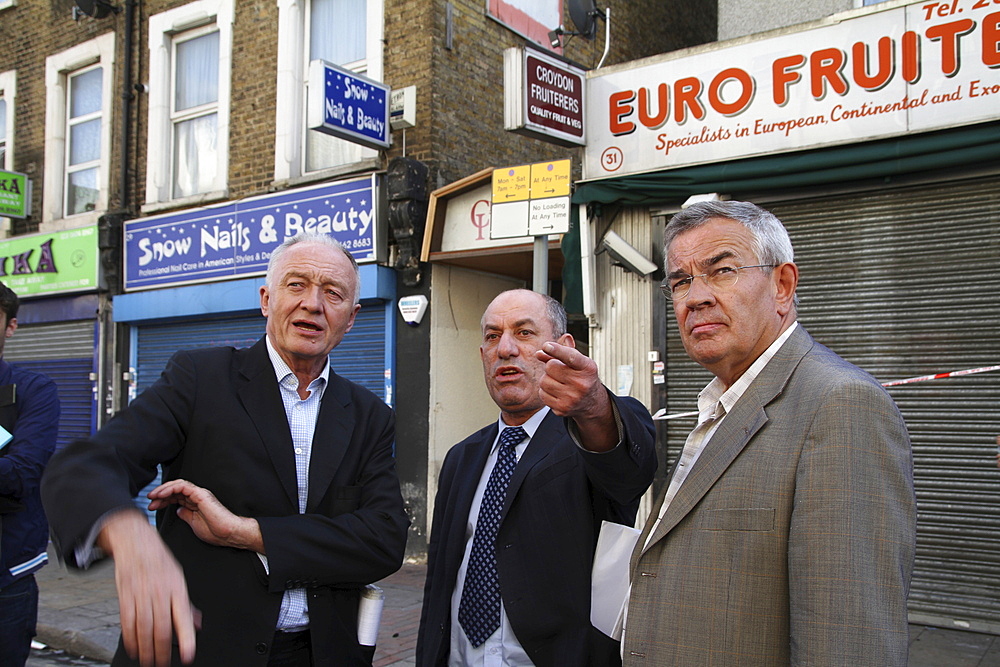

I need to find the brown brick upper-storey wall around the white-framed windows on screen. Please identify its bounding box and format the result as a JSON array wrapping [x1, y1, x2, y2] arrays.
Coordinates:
[[0, 0, 716, 233]]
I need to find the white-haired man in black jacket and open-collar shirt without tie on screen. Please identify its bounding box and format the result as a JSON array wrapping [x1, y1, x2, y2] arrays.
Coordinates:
[[43, 235, 408, 667]]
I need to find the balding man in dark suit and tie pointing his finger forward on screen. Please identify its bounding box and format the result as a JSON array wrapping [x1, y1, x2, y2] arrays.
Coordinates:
[[417, 290, 656, 667]]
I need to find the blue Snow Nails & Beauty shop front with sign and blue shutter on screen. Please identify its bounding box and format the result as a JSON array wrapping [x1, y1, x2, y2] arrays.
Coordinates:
[[114, 176, 396, 520]]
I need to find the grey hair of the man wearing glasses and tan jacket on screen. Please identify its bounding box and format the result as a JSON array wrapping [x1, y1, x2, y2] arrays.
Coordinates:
[[663, 201, 795, 266]]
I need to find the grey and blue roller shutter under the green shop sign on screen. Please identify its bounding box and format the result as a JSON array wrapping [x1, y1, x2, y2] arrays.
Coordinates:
[[3, 320, 95, 448]]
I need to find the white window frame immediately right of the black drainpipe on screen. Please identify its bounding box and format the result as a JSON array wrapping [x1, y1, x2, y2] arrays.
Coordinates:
[[142, 0, 233, 213]]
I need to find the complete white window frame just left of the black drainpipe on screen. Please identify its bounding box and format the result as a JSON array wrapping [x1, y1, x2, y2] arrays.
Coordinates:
[[39, 32, 115, 232]]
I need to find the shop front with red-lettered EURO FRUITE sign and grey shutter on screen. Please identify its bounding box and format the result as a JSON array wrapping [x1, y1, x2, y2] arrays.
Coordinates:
[[567, 3, 1000, 633]]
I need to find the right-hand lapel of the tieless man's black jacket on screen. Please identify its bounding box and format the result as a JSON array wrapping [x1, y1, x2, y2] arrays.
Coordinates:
[[306, 369, 354, 512]]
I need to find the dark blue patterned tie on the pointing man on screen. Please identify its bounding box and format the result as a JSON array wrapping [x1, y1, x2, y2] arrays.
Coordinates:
[[458, 426, 528, 646]]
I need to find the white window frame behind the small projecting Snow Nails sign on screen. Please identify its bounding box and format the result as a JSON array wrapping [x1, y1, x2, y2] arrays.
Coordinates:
[[274, 0, 385, 184]]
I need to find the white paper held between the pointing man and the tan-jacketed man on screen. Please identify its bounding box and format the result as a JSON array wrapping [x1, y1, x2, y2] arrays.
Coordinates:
[[590, 521, 642, 639]]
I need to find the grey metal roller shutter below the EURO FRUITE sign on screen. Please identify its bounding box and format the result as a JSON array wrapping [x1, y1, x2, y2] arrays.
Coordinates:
[[667, 177, 1000, 633]]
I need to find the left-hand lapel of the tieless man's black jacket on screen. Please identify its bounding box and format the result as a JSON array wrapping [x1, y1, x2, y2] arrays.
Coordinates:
[[237, 338, 299, 507]]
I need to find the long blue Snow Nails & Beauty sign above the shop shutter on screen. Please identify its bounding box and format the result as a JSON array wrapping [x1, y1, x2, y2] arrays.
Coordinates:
[[125, 175, 385, 291]]
